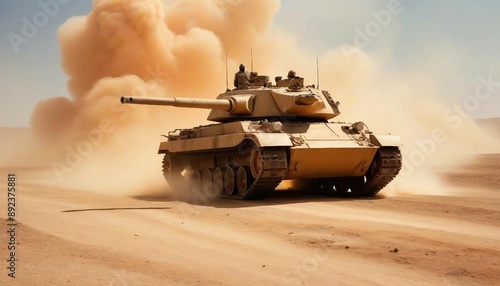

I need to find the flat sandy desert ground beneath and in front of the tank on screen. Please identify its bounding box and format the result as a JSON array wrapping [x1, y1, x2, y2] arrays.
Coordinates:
[[0, 155, 500, 285]]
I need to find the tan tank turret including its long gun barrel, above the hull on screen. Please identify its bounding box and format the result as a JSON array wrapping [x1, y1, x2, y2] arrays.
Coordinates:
[[121, 72, 340, 122]]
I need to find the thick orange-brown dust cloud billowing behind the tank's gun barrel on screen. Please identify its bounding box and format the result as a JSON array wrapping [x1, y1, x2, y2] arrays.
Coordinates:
[[31, 0, 279, 195]]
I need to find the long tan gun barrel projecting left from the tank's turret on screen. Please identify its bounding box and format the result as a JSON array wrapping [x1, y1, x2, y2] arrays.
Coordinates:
[[120, 94, 253, 114]]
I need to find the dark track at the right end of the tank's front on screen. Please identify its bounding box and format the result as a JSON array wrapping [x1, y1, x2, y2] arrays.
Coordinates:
[[360, 147, 403, 197]]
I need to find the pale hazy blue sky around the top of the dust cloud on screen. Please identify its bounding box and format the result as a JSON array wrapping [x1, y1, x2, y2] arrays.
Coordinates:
[[0, 0, 500, 127]]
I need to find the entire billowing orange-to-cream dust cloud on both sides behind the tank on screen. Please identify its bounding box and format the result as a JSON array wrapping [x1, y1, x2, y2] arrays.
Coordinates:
[[31, 0, 500, 195]]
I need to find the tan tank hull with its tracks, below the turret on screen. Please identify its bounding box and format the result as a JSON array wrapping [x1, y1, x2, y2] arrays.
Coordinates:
[[158, 121, 401, 199]]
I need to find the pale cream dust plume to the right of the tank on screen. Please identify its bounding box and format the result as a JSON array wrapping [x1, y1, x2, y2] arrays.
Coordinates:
[[316, 47, 500, 196]]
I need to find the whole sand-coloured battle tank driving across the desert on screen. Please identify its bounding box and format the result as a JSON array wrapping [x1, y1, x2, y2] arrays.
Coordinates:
[[121, 72, 402, 199]]
